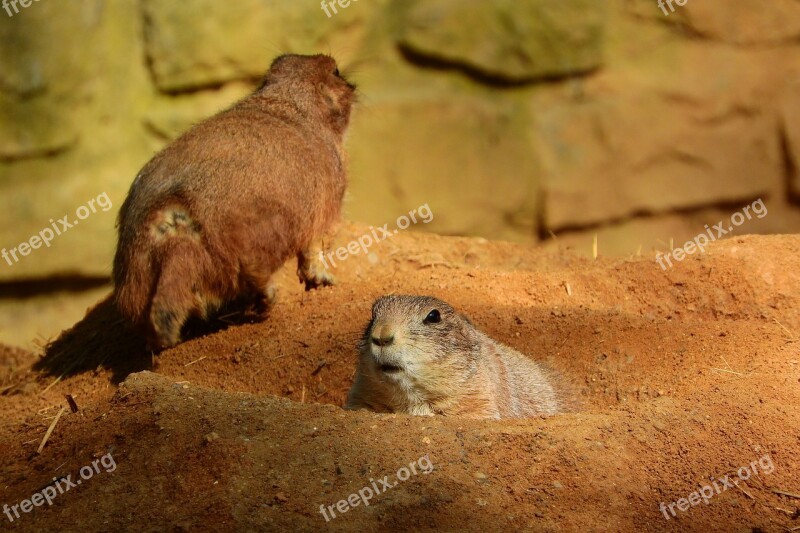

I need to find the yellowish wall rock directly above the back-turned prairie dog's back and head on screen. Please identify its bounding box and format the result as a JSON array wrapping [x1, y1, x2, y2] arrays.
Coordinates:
[[143, 0, 374, 92]]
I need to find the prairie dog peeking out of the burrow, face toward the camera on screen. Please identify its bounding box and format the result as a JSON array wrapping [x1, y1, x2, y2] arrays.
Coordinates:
[[346, 296, 566, 418]]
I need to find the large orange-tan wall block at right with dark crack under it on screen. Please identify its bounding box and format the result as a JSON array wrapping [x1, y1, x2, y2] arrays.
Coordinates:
[[533, 41, 783, 230]]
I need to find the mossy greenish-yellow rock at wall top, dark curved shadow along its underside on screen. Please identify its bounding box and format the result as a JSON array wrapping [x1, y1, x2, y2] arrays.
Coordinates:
[[398, 0, 605, 81]]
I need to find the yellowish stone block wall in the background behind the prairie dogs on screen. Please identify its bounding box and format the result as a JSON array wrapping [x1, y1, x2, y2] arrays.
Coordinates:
[[0, 0, 800, 280]]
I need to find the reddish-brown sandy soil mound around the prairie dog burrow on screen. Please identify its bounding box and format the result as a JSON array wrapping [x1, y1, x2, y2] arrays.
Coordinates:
[[0, 226, 800, 532]]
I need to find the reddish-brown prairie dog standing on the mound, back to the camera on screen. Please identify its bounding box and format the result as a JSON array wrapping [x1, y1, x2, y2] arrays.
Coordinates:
[[114, 55, 355, 349]]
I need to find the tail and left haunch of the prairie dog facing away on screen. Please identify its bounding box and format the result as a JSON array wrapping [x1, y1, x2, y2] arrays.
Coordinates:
[[114, 205, 210, 348]]
